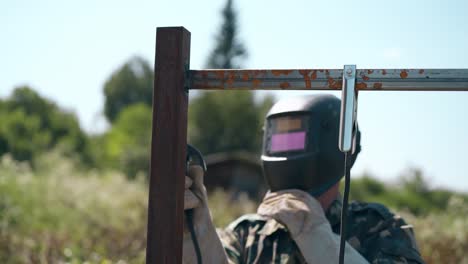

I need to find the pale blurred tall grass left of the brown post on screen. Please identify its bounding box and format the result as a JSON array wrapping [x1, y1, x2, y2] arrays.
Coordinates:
[[0, 154, 147, 263]]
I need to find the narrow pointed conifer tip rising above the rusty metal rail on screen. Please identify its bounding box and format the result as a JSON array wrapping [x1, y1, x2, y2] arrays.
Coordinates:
[[207, 0, 247, 69]]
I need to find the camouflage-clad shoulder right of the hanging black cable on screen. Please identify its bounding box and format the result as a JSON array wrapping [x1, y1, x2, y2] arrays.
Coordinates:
[[349, 202, 423, 263]]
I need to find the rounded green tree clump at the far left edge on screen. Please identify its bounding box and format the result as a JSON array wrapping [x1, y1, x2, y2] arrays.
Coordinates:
[[0, 86, 92, 164]]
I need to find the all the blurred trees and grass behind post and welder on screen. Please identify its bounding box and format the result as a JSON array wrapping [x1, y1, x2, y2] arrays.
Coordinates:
[[0, 0, 468, 263]]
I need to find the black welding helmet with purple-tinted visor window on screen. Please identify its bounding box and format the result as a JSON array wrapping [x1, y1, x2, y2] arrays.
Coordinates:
[[262, 95, 361, 197]]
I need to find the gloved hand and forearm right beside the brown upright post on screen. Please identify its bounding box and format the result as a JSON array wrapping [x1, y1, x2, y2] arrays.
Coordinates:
[[183, 166, 228, 264]]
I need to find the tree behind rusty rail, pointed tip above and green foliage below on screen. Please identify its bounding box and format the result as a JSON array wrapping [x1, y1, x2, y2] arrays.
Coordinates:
[[188, 0, 273, 153]]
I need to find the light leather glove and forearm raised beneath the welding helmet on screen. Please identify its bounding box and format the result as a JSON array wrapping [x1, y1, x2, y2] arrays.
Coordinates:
[[257, 190, 368, 264]]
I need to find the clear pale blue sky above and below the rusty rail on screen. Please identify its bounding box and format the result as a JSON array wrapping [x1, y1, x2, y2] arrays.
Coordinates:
[[0, 0, 468, 191]]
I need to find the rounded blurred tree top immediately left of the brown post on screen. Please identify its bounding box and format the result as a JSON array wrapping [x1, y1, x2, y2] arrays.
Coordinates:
[[104, 57, 154, 122]]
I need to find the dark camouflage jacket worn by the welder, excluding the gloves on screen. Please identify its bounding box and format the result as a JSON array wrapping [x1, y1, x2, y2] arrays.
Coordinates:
[[219, 199, 424, 264]]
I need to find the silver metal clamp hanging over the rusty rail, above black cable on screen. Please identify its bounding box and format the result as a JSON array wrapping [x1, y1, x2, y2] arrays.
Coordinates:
[[338, 65, 357, 152]]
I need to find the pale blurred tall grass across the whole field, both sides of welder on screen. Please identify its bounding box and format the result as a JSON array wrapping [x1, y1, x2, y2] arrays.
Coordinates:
[[0, 153, 468, 264]]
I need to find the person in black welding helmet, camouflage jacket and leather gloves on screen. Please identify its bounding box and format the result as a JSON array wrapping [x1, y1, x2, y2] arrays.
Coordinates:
[[183, 95, 424, 264]]
